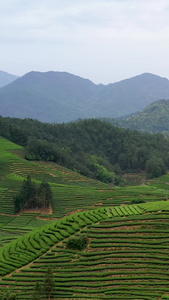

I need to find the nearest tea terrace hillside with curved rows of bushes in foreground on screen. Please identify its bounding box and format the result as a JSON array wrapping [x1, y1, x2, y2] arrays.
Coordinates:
[[0, 201, 169, 300]]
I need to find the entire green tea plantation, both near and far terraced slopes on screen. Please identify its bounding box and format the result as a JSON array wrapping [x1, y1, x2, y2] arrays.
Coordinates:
[[0, 138, 169, 300]]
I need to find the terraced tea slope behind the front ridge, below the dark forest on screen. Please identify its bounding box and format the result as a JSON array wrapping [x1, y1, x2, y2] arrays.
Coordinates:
[[0, 138, 168, 218]]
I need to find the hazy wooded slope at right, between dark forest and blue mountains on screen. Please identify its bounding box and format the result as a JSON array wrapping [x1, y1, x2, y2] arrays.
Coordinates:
[[102, 100, 169, 135]]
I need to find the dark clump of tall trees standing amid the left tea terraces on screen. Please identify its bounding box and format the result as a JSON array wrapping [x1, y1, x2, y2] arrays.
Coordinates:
[[14, 175, 53, 213]]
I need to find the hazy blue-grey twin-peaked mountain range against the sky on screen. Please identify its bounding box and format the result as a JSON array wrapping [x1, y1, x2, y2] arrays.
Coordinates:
[[0, 72, 169, 123]]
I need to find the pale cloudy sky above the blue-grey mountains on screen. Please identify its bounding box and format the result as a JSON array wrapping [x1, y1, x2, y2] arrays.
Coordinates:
[[0, 0, 169, 84]]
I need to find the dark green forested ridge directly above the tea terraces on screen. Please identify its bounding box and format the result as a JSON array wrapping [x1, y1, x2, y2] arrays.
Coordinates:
[[0, 117, 169, 184]]
